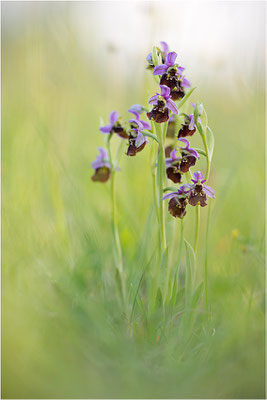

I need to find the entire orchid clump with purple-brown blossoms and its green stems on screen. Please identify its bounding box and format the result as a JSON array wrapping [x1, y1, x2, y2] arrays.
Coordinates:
[[91, 42, 215, 318]]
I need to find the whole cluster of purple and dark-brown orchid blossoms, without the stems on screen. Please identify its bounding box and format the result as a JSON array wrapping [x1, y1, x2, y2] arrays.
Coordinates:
[[92, 42, 214, 218]]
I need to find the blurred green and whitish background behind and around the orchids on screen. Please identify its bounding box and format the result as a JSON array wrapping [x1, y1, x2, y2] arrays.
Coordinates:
[[2, 2, 265, 398]]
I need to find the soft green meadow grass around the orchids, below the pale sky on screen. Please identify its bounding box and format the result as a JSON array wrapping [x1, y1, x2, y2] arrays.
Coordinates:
[[2, 7, 264, 398]]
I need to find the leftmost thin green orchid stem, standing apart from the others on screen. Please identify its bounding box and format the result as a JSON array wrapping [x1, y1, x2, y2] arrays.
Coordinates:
[[107, 136, 126, 305]]
